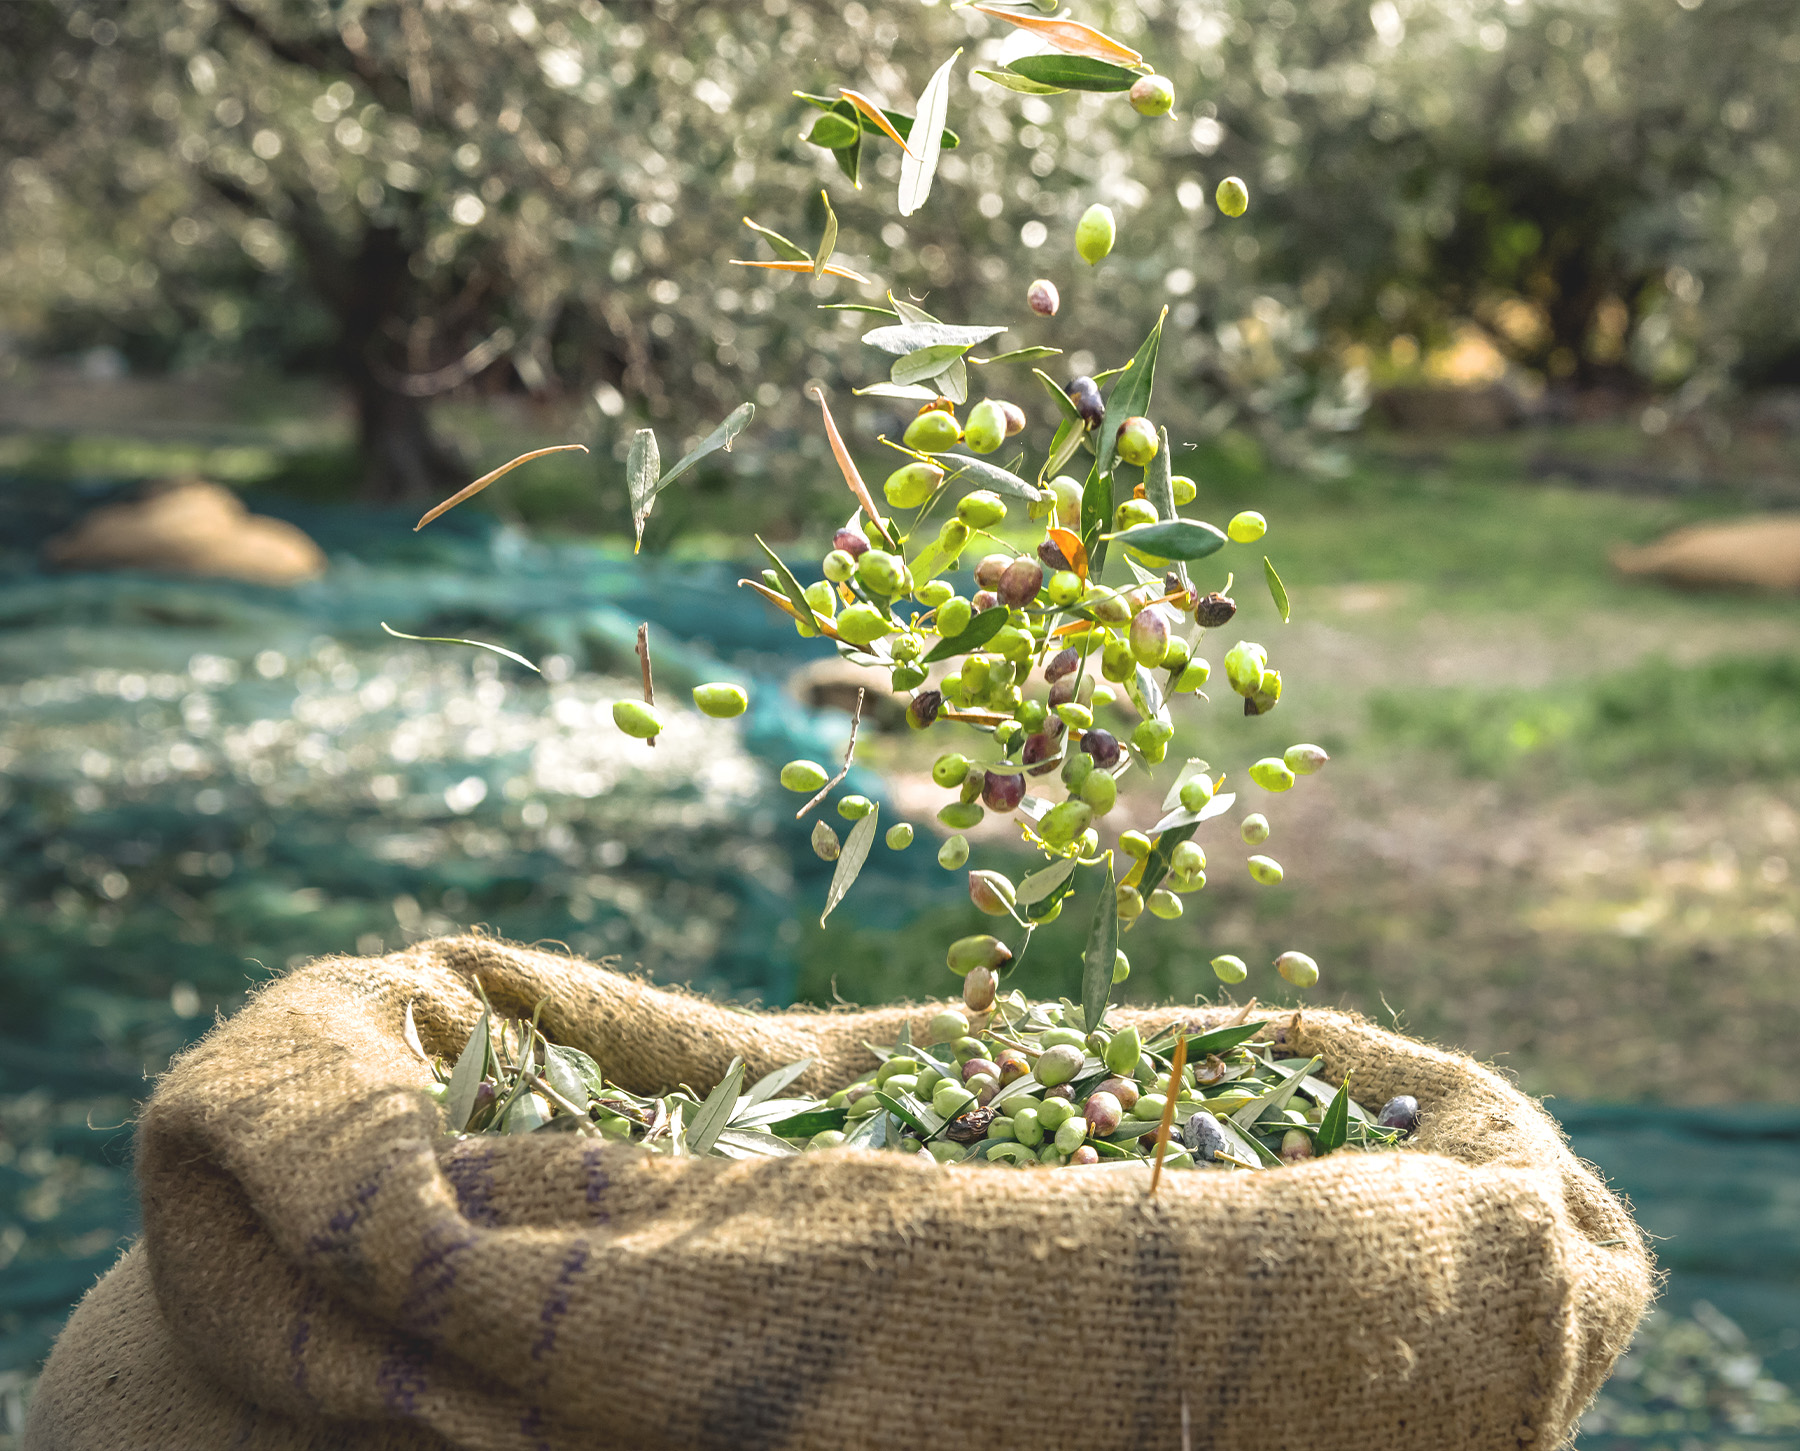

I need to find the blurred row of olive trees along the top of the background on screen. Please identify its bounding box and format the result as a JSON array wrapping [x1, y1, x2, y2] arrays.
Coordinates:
[[0, 0, 1800, 511]]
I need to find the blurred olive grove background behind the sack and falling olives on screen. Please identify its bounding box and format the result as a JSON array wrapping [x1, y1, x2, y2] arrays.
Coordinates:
[[0, 0, 1800, 1451]]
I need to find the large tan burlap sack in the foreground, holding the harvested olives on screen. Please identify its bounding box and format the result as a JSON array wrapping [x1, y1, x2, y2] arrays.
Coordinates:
[[25, 938, 1651, 1451]]
